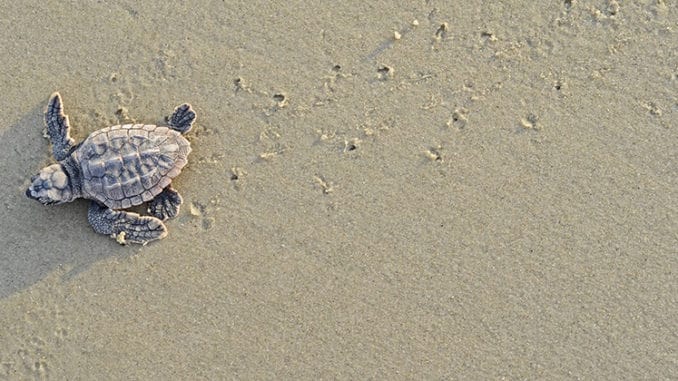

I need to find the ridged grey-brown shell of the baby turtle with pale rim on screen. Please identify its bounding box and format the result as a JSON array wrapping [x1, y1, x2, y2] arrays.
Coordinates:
[[73, 124, 191, 209]]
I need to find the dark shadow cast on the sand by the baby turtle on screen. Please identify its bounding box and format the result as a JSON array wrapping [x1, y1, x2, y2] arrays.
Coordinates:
[[0, 99, 137, 298]]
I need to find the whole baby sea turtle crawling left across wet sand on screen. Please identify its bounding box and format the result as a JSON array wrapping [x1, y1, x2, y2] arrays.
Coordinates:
[[26, 93, 195, 245]]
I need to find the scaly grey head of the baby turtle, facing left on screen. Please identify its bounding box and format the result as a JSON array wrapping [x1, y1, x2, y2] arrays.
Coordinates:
[[26, 164, 74, 205]]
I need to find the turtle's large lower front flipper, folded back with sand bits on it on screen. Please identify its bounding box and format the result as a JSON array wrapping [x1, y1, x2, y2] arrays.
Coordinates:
[[87, 201, 167, 245]]
